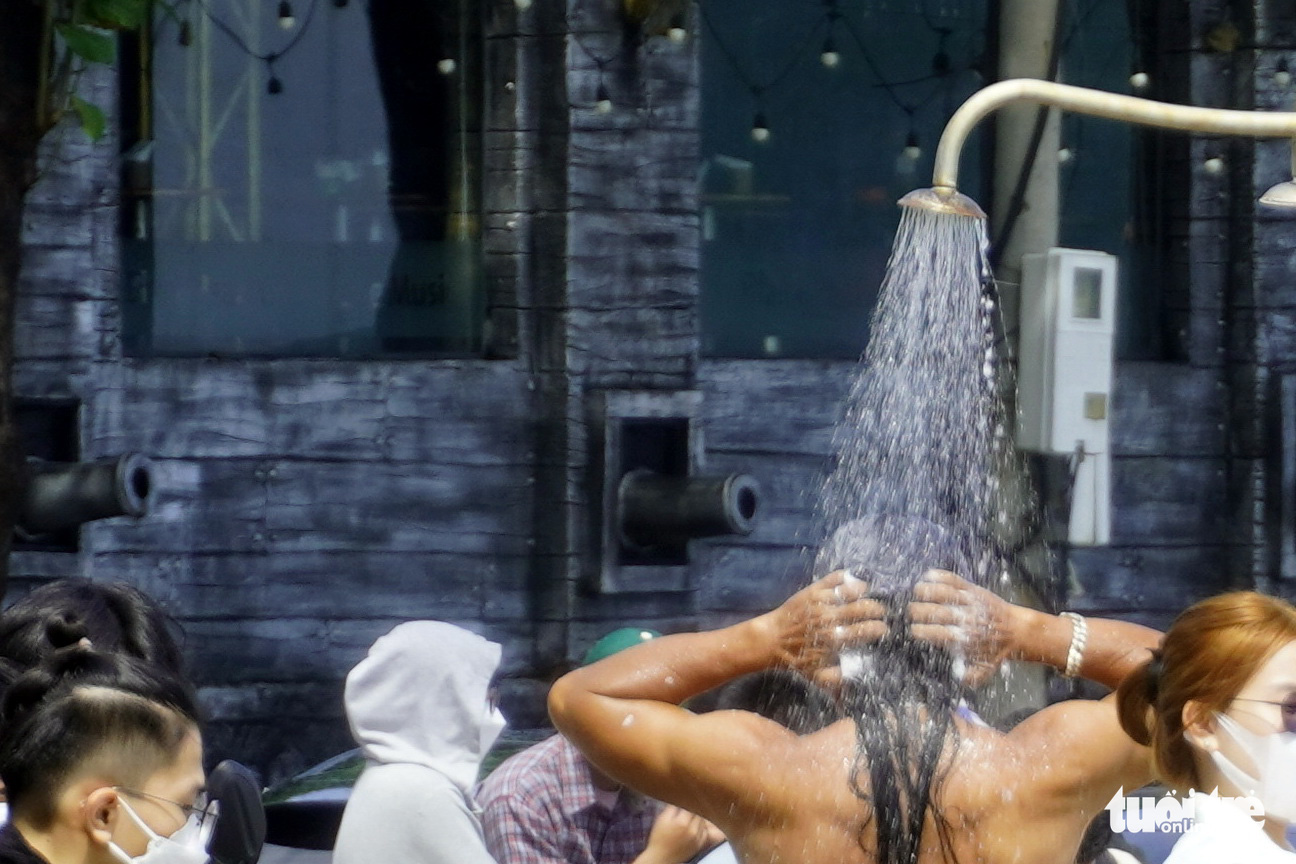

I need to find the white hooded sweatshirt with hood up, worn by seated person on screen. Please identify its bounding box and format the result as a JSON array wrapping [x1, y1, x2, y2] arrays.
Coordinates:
[[333, 620, 504, 864]]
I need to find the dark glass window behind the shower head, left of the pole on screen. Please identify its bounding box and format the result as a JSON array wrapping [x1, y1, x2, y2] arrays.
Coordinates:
[[700, 0, 993, 359]]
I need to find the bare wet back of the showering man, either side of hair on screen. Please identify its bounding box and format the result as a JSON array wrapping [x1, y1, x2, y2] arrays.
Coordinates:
[[712, 702, 1147, 864]]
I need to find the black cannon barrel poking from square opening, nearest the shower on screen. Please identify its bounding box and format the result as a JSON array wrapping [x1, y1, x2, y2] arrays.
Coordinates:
[[618, 469, 761, 547]]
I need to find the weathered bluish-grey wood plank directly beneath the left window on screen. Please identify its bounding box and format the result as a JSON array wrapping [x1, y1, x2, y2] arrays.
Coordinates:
[[87, 363, 530, 465]]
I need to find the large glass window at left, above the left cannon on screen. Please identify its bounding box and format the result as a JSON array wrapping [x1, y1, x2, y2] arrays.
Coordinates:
[[122, 0, 483, 356]]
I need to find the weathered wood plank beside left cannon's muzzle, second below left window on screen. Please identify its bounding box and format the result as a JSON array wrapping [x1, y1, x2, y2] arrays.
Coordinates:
[[84, 460, 531, 554]]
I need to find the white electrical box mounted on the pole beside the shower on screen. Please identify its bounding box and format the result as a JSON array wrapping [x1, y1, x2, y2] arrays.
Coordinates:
[[1017, 249, 1117, 545]]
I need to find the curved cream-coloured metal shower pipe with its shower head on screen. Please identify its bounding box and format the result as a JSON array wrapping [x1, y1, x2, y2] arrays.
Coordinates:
[[908, 78, 1296, 216]]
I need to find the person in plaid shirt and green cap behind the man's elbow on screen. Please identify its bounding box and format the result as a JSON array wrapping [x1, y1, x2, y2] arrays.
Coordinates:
[[477, 628, 723, 864]]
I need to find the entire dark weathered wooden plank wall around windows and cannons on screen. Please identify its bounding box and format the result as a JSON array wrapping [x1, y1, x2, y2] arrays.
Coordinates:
[[12, 0, 1296, 780]]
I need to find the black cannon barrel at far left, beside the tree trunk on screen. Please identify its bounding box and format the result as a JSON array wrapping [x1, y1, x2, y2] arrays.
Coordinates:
[[18, 453, 153, 535]]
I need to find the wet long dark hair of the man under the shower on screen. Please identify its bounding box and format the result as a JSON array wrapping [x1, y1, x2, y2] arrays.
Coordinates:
[[815, 517, 968, 864]]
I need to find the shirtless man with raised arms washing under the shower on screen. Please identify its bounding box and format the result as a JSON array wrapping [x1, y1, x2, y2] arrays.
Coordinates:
[[550, 571, 1160, 864]]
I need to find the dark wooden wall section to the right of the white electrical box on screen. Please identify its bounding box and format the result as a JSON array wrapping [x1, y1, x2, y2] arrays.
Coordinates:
[[1069, 1, 1296, 626]]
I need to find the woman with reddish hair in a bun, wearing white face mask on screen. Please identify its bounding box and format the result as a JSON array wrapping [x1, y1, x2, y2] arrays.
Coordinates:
[[1117, 592, 1296, 864]]
